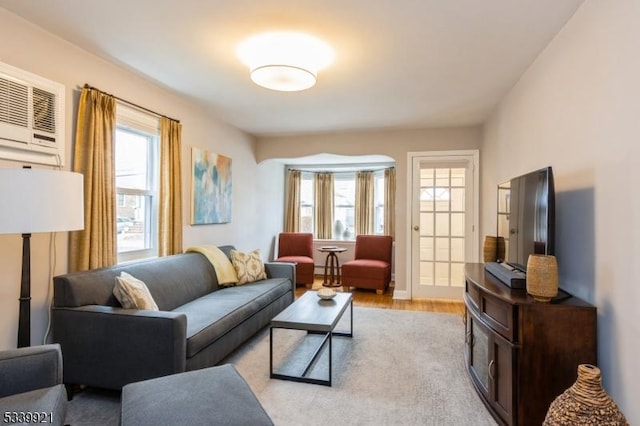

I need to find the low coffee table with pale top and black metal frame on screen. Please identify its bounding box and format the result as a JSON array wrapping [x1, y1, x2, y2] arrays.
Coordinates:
[[269, 291, 353, 386]]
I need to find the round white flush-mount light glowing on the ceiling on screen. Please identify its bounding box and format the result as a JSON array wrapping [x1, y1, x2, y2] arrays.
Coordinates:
[[237, 31, 334, 92]]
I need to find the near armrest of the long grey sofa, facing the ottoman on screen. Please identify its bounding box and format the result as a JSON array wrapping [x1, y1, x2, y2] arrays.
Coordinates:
[[52, 305, 187, 389]]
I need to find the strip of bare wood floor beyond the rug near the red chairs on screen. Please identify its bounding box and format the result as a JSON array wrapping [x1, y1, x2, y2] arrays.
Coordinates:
[[296, 277, 464, 315]]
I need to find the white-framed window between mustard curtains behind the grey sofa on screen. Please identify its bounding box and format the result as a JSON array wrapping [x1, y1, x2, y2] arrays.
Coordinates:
[[115, 103, 159, 262]]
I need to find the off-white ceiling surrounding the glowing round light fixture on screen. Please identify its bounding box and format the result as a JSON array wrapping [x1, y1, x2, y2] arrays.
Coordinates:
[[0, 0, 583, 135]]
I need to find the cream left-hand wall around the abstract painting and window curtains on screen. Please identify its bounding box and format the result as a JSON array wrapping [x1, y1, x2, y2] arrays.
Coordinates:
[[0, 8, 283, 349]]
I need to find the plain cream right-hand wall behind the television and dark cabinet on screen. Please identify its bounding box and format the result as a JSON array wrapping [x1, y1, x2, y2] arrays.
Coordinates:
[[482, 0, 640, 424]]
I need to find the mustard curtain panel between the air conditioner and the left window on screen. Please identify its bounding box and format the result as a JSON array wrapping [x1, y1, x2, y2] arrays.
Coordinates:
[[69, 87, 117, 271]]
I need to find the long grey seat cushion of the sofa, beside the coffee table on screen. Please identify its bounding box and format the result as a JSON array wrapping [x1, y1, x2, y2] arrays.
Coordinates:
[[173, 278, 291, 358]]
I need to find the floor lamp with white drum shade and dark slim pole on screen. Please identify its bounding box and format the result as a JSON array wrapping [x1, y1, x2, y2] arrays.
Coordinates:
[[0, 168, 84, 348]]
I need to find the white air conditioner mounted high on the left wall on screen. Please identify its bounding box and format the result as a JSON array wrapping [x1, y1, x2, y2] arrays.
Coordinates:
[[0, 62, 65, 166]]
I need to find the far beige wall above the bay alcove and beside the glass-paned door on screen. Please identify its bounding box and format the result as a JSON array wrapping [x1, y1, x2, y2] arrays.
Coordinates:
[[256, 127, 482, 293]]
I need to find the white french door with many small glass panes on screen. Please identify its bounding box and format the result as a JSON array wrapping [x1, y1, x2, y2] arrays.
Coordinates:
[[408, 151, 478, 299]]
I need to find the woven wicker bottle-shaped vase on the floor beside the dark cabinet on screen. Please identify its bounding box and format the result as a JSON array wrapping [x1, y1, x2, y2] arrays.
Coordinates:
[[543, 364, 629, 426]]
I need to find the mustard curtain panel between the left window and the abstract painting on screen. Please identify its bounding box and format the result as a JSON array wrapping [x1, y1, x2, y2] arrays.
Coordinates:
[[158, 117, 182, 256]]
